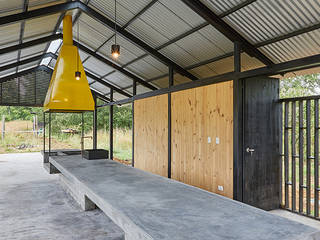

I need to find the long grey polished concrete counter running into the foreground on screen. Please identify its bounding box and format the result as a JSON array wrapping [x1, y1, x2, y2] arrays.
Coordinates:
[[50, 156, 320, 240]]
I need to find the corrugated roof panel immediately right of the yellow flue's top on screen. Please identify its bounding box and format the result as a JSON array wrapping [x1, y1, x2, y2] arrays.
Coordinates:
[[73, 14, 114, 50]]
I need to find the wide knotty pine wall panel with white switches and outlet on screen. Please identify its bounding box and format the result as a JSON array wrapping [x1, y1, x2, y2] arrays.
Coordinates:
[[171, 81, 233, 198]]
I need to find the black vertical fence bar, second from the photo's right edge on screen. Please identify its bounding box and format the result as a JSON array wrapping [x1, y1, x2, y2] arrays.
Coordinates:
[[307, 100, 311, 215]]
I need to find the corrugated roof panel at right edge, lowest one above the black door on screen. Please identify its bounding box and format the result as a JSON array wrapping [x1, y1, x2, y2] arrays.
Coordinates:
[[259, 29, 320, 63]]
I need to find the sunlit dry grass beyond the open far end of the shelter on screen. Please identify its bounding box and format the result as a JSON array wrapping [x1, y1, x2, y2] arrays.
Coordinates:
[[0, 121, 132, 163]]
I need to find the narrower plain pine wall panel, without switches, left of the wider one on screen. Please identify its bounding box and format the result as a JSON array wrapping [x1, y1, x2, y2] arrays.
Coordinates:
[[134, 95, 168, 177]]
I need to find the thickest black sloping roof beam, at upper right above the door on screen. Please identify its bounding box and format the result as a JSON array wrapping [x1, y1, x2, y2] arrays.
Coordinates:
[[182, 0, 274, 66]]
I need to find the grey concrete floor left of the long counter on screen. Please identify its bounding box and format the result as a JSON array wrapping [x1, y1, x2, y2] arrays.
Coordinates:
[[0, 153, 124, 240]]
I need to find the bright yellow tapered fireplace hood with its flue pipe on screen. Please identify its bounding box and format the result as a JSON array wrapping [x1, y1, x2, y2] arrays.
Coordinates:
[[44, 16, 94, 112]]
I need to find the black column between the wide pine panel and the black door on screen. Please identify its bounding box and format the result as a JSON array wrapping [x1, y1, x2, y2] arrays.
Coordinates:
[[233, 42, 244, 201]]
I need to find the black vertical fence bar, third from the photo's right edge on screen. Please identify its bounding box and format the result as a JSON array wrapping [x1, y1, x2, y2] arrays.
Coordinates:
[[299, 100, 304, 213]]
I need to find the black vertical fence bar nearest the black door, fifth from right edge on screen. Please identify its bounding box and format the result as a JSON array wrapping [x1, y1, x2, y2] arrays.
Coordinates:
[[284, 102, 289, 208]]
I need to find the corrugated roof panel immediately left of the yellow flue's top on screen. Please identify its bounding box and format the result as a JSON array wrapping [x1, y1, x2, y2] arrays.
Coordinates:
[[23, 14, 60, 38]]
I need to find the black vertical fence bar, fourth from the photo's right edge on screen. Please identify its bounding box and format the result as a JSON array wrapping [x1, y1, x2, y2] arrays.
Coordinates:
[[291, 101, 296, 211]]
